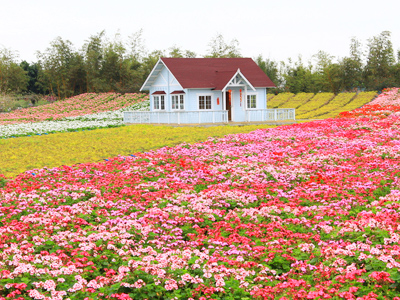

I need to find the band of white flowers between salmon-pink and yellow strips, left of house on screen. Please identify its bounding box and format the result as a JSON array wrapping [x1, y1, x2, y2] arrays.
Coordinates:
[[0, 101, 150, 138]]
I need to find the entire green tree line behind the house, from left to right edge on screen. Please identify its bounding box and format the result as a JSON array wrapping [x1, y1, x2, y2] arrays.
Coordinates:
[[0, 30, 400, 99]]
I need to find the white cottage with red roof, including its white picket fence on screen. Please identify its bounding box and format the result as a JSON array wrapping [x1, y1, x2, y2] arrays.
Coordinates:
[[124, 58, 294, 123]]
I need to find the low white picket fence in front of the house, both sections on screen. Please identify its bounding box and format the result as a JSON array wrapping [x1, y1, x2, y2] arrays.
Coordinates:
[[123, 108, 296, 124]]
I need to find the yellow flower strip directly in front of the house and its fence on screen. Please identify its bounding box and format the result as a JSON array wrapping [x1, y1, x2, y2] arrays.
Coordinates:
[[0, 125, 274, 177]]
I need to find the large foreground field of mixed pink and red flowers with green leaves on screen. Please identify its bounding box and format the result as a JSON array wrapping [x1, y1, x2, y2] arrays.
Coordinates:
[[0, 88, 400, 300]]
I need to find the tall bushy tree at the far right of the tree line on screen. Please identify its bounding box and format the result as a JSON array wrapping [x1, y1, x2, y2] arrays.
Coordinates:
[[365, 31, 395, 90]]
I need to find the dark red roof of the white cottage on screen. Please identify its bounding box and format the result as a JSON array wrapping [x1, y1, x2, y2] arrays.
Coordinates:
[[161, 57, 275, 90]]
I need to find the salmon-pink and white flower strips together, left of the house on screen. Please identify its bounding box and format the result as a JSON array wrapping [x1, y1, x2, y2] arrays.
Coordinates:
[[0, 93, 150, 138]]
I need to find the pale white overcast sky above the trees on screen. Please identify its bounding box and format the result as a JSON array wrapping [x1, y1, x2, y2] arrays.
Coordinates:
[[0, 0, 400, 62]]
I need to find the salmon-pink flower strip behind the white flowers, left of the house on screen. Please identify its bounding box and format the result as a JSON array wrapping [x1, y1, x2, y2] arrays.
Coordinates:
[[0, 93, 148, 125]]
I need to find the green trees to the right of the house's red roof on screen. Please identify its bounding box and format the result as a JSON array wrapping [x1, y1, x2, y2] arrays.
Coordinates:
[[256, 31, 400, 94]]
